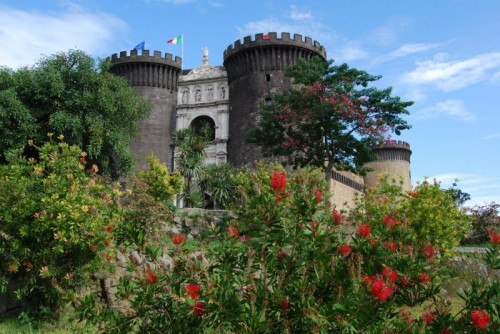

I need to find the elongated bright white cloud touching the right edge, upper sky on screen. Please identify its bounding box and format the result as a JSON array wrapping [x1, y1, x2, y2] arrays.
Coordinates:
[[403, 52, 500, 92]]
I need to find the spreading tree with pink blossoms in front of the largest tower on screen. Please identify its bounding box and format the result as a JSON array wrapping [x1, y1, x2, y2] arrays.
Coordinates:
[[248, 58, 413, 178]]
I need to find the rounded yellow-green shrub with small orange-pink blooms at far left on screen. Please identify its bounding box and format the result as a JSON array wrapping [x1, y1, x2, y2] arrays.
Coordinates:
[[0, 137, 121, 312]]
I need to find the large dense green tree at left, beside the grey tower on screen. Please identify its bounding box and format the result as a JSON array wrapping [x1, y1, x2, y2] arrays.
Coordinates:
[[0, 50, 151, 178]]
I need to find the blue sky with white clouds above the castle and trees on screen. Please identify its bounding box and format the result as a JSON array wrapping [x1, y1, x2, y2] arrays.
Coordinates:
[[0, 0, 500, 206]]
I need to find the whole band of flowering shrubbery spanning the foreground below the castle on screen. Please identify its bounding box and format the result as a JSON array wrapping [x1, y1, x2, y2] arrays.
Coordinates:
[[0, 146, 500, 333]]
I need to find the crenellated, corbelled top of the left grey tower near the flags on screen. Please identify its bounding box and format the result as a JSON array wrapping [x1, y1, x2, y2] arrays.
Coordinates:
[[111, 50, 182, 91]]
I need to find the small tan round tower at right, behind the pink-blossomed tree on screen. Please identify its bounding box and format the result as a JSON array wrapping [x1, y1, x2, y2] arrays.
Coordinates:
[[364, 140, 411, 191]]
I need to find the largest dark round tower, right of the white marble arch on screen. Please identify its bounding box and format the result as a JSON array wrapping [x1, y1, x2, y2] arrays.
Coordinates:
[[224, 33, 326, 166]]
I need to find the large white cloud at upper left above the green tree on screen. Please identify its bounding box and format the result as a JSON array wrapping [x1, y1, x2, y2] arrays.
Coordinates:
[[0, 6, 126, 68]]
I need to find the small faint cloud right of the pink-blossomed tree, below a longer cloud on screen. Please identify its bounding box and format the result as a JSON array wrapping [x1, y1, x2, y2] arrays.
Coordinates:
[[412, 100, 476, 122]]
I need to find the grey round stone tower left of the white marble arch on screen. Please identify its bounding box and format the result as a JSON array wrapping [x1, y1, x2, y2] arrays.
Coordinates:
[[111, 50, 182, 169]]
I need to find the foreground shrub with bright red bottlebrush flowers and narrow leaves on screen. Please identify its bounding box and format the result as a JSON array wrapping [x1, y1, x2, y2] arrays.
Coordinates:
[[65, 165, 500, 333]]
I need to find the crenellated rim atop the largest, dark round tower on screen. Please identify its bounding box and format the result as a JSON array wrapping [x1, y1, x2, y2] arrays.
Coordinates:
[[224, 32, 326, 60]]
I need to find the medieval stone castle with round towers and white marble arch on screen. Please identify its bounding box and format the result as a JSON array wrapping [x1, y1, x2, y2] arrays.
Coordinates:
[[111, 33, 411, 209]]
